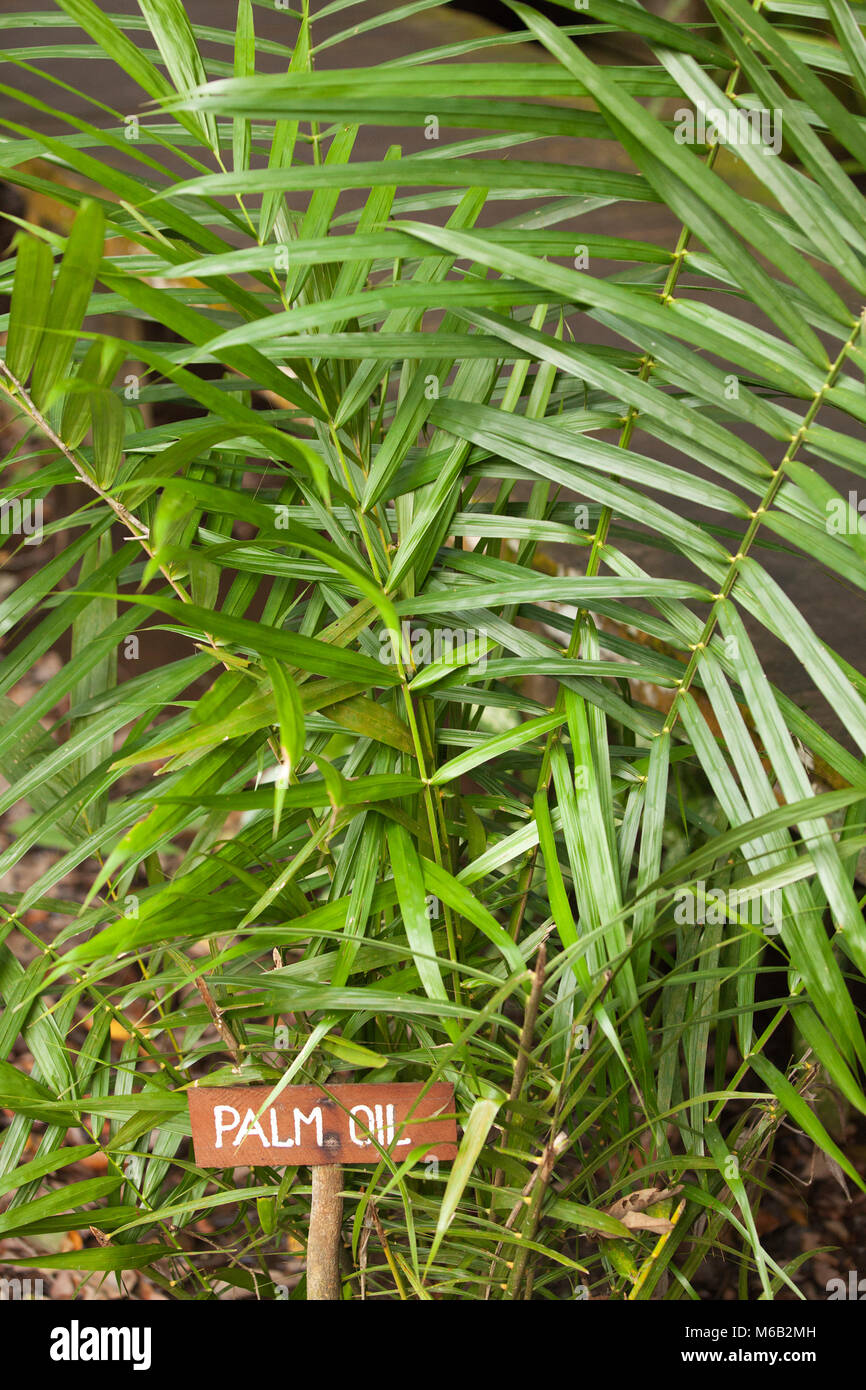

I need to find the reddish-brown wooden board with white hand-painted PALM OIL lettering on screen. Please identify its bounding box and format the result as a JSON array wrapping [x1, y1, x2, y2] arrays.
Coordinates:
[[188, 1081, 457, 1168]]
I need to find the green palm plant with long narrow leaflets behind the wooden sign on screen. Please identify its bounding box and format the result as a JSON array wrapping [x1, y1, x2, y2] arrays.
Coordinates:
[[0, 0, 866, 1300]]
